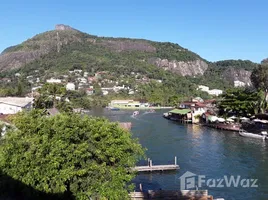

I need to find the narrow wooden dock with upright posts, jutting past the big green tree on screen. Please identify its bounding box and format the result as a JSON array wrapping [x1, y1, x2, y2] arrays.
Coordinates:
[[132, 156, 180, 172]]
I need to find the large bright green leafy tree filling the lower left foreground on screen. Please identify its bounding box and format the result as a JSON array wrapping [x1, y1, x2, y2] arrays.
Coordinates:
[[0, 110, 144, 199]]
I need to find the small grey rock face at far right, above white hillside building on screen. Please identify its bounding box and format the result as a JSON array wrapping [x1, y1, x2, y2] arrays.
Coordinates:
[[223, 67, 251, 85]]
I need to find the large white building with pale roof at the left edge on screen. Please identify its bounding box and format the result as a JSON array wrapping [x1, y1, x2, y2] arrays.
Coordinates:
[[0, 97, 33, 114]]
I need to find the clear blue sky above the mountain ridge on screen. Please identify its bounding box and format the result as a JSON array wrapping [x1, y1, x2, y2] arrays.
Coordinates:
[[0, 0, 268, 62]]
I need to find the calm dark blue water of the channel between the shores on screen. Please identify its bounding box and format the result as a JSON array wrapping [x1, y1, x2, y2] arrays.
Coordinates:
[[89, 110, 268, 200]]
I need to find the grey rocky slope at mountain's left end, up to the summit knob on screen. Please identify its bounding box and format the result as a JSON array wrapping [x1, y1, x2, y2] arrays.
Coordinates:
[[0, 24, 82, 71]]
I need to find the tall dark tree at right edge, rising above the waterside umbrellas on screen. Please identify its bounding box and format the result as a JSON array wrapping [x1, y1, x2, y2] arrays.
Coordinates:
[[250, 64, 268, 112]]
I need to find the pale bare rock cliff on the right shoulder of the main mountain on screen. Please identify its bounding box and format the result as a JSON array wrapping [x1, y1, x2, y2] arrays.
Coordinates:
[[148, 58, 208, 76]]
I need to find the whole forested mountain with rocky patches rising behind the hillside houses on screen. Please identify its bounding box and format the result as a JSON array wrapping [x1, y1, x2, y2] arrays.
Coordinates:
[[0, 25, 256, 101]]
